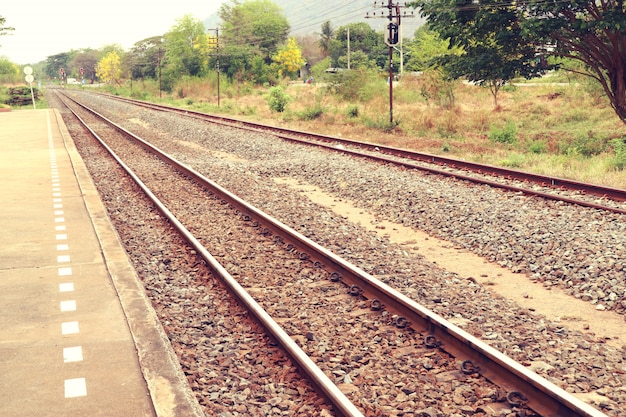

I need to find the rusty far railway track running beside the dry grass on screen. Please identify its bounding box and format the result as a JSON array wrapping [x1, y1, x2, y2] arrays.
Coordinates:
[[92, 92, 626, 214]]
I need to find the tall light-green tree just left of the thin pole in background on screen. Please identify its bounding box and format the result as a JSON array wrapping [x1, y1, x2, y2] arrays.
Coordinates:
[[165, 15, 208, 77]]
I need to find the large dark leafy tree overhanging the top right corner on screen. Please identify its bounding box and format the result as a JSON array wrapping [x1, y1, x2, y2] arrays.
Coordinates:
[[412, 0, 626, 124]]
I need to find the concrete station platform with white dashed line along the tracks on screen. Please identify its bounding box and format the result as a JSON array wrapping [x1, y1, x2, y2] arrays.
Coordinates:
[[0, 109, 203, 417]]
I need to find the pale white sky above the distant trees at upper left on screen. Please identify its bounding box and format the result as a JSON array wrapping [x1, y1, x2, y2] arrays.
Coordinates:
[[0, 0, 226, 65]]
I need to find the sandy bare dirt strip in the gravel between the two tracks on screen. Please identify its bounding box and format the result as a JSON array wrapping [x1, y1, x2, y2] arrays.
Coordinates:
[[275, 178, 626, 348]]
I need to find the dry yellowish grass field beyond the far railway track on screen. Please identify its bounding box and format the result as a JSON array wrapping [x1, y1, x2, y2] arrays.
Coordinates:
[[141, 75, 626, 188]]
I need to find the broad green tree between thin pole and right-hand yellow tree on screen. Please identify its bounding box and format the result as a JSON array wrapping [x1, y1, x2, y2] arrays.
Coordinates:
[[219, 0, 290, 74]]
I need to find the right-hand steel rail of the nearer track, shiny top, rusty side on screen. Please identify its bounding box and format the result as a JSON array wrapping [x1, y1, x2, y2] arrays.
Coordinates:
[[59, 92, 606, 417]]
